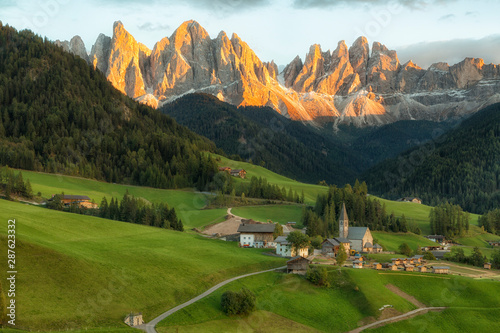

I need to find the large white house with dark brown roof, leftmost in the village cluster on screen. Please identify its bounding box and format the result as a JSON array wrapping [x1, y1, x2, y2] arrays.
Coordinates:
[[238, 221, 275, 248]]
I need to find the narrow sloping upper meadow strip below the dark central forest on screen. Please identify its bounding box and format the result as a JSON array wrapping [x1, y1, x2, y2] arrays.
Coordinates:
[[214, 155, 328, 204]]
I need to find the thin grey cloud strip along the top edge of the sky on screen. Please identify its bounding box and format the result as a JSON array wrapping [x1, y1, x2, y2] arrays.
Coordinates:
[[293, 0, 457, 9]]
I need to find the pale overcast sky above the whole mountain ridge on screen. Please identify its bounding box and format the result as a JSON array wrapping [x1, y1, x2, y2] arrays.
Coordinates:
[[0, 0, 500, 68]]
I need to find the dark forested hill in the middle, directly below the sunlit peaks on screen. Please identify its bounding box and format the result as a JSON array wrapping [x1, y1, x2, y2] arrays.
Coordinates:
[[161, 94, 363, 184]]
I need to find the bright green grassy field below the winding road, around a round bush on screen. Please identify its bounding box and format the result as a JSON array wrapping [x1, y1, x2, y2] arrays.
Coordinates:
[[158, 269, 415, 332]]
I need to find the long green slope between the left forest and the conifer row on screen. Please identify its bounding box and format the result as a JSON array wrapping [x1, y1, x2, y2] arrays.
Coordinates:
[[16, 171, 226, 227]]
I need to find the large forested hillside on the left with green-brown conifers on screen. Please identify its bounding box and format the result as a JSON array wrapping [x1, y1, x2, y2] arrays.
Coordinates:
[[0, 23, 217, 188]]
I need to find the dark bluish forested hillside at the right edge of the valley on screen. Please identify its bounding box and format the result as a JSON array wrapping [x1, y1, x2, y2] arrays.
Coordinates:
[[364, 104, 500, 213]]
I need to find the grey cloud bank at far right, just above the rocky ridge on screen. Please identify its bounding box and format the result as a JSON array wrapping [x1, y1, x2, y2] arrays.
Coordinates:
[[396, 34, 500, 68]]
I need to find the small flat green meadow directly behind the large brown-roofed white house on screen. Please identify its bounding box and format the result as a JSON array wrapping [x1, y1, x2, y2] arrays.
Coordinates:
[[231, 205, 302, 224]]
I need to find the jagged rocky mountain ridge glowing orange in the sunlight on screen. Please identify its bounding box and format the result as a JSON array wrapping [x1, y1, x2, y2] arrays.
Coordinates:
[[56, 21, 500, 127]]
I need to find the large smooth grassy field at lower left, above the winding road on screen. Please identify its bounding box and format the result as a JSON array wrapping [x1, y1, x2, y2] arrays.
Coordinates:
[[0, 200, 285, 330]]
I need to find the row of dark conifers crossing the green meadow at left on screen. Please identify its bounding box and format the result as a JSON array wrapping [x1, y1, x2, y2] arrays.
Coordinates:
[[47, 190, 184, 231]]
